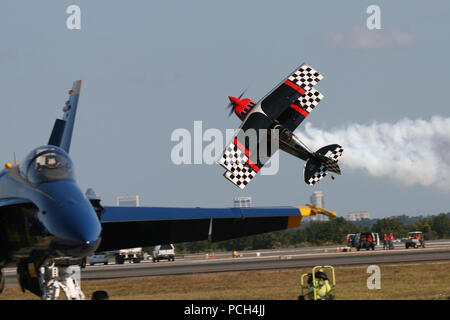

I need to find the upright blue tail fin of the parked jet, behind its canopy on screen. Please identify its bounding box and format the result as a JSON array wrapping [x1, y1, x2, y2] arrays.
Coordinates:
[[48, 80, 81, 153]]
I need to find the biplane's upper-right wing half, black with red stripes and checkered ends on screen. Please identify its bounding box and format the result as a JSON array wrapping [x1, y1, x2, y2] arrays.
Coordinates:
[[250, 64, 323, 125]]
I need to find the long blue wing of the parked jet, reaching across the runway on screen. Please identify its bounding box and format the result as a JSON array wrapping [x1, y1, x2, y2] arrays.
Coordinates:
[[97, 207, 305, 251]]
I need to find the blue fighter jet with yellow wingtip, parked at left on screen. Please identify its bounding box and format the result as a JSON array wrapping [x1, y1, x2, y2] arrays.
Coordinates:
[[0, 80, 324, 299]]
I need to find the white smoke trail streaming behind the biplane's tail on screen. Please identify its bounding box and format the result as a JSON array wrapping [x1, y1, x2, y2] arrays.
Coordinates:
[[297, 116, 450, 192]]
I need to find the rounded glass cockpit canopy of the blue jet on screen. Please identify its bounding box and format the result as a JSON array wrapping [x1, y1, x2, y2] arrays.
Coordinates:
[[22, 146, 74, 183]]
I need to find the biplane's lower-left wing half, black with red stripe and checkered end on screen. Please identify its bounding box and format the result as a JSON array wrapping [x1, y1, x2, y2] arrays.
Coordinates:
[[218, 112, 278, 189]]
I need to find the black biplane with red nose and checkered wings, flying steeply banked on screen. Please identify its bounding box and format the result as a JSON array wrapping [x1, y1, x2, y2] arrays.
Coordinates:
[[218, 64, 344, 189]]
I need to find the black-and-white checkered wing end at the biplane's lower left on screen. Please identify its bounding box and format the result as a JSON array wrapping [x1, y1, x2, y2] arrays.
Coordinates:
[[218, 140, 257, 189]]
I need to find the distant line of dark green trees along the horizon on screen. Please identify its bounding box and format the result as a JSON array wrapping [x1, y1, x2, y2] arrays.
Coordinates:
[[175, 213, 450, 253]]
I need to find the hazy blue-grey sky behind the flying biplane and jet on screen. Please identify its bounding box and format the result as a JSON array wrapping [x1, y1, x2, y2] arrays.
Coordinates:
[[0, 0, 450, 218]]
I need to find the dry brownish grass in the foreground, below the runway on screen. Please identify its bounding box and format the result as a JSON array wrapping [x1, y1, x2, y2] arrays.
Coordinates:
[[0, 261, 450, 300]]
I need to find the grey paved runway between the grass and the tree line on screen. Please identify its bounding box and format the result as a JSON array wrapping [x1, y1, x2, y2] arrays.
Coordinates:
[[5, 240, 450, 284]]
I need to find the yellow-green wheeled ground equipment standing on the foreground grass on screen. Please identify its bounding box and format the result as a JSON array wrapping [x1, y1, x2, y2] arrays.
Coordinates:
[[298, 266, 336, 300]]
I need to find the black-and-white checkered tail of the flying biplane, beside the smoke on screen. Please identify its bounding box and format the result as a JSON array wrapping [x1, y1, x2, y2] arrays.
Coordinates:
[[303, 144, 344, 185]]
